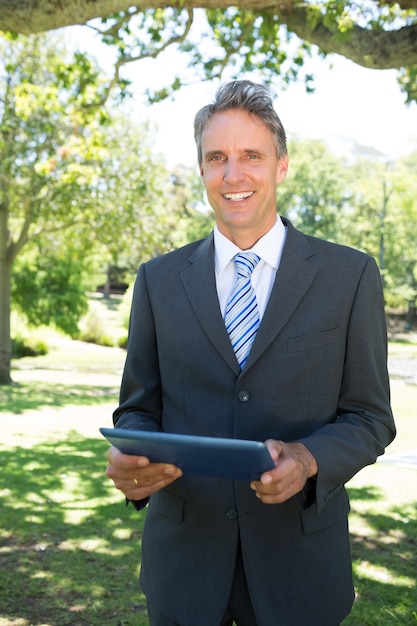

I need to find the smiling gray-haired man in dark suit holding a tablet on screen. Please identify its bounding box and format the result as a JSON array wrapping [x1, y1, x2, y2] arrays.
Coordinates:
[[107, 81, 395, 626]]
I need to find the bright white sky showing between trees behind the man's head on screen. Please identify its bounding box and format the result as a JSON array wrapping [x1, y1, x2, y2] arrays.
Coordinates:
[[65, 27, 417, 166]]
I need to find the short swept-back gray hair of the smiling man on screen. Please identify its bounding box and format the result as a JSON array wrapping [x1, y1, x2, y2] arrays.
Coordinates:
[[194, 80, 287, 165]]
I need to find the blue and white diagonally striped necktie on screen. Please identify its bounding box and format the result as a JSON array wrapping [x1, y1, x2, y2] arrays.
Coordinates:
[[224, 252, 260, 368]]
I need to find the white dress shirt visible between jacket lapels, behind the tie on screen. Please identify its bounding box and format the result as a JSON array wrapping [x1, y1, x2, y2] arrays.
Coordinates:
[[214, 216, 287, 319]]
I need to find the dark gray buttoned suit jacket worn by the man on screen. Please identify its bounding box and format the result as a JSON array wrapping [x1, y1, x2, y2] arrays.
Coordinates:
[[114, 220, 395, 626]]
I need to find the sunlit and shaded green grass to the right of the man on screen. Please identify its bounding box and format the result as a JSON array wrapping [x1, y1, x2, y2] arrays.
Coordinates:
[[343, 381, 417, 626]]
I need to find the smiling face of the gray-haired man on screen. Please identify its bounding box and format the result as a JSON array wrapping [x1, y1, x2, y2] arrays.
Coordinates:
[[200, 109, 288, 249]]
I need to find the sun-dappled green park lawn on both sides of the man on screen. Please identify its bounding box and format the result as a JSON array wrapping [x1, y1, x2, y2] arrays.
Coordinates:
[[0, 354, 417, 626]]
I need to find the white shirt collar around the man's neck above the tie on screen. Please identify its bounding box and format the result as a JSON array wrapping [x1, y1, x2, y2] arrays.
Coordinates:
[[214, 216, 286, 275]]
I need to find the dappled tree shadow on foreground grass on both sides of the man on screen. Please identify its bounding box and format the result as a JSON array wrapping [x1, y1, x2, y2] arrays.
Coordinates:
[[0, 432, 417, 626]]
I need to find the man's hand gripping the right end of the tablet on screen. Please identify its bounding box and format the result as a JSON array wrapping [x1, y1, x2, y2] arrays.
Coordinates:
[[251, 439, 317, 504]]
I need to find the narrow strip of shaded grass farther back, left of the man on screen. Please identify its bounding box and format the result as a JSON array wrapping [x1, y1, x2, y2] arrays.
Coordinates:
[[0, 381, 119, 413]]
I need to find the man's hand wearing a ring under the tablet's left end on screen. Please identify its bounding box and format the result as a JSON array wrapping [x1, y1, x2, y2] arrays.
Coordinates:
[[106, 446, 182, 500]]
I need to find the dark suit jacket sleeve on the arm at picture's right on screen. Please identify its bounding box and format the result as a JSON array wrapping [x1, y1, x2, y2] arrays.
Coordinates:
[[300, 258, 395, 512]]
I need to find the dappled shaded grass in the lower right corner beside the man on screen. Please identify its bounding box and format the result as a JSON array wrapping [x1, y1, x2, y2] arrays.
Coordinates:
[[343, 486, 417, 626]]
